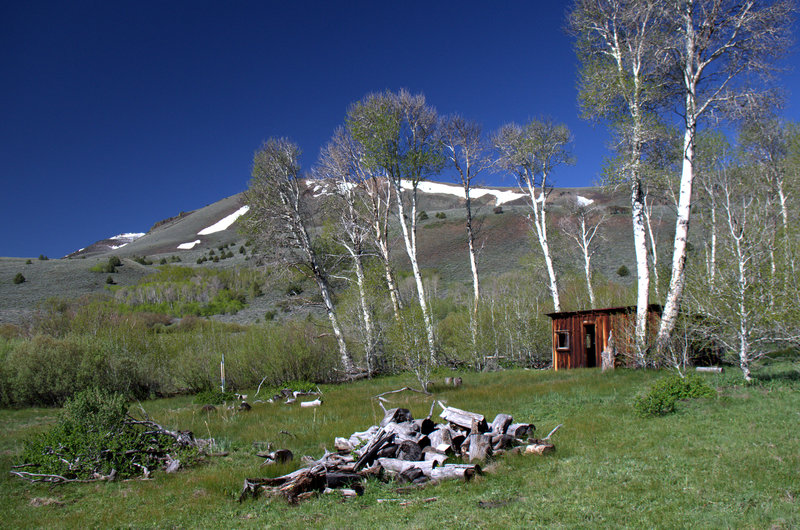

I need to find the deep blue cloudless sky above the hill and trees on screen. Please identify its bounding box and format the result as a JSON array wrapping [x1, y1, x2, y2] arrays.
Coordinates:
[[0, 0, 800, 257]]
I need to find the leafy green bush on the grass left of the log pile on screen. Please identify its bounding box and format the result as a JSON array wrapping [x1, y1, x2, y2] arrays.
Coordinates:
[[22, 388, 197, 480]]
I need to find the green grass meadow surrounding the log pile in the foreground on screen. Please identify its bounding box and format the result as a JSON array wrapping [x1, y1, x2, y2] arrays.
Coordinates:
[[0, 360, 800, 528]]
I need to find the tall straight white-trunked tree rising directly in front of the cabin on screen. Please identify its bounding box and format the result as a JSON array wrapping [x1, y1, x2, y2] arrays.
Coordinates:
[[569, 0, 672, 358]]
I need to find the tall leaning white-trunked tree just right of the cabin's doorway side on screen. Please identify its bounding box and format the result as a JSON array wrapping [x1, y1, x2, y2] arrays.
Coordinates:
[[656, 0, 795, 351]]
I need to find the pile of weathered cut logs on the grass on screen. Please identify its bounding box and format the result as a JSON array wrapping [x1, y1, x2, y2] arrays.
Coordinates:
[[239, 402, 555, 503]]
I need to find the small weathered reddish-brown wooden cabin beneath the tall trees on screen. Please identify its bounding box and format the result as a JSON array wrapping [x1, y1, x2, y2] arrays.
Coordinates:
[[547, 304, 661, 370]]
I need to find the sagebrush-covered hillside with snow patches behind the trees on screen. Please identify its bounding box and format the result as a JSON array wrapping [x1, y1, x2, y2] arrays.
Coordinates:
[[0, 181, 674, 323]]
